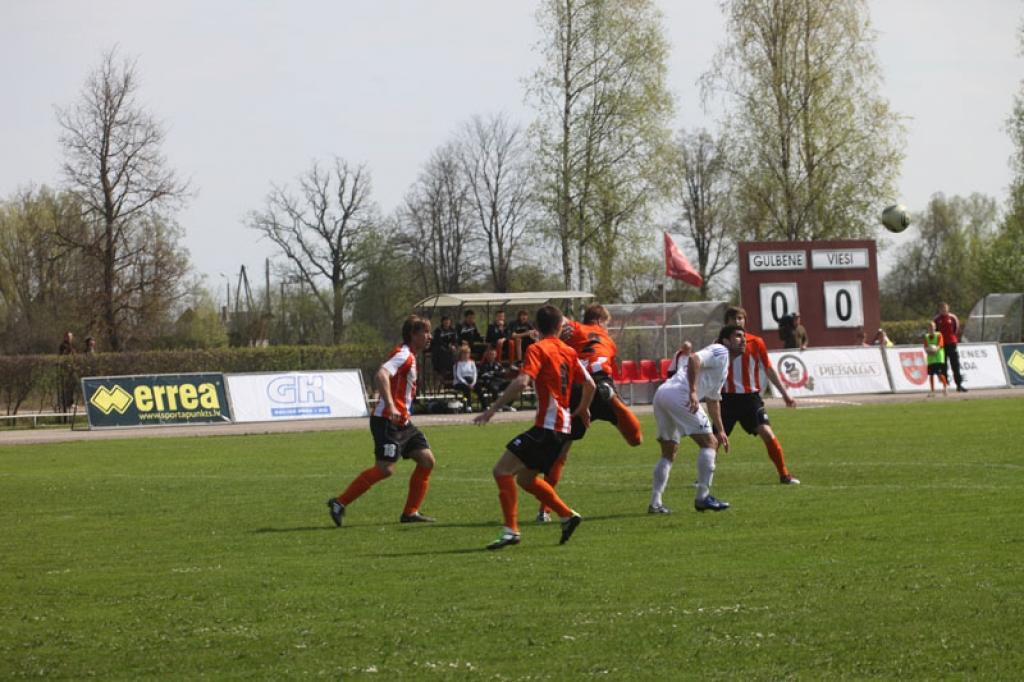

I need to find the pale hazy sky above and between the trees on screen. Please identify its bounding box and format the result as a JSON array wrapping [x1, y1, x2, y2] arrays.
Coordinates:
[[0, 0, 1024, 290]]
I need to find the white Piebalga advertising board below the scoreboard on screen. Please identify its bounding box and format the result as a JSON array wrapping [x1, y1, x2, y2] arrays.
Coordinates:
[[768, 348, 892, 397]]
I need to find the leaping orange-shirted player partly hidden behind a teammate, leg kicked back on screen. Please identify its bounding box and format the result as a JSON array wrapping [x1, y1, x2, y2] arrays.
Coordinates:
[[537, 304, 643, 523]]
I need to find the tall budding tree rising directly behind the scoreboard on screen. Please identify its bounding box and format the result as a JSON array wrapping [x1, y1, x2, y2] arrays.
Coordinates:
[[705, 0, 903, 240]]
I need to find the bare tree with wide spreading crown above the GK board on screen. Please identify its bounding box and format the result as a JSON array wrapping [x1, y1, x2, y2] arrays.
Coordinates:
[[248, 158, 379, 343]]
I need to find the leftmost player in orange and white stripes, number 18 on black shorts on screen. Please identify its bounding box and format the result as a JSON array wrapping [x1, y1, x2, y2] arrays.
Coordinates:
[[327, 315, 434, 526]]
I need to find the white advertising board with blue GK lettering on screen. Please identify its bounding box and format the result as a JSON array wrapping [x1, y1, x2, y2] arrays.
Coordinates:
[[224, 370, 369, 422]]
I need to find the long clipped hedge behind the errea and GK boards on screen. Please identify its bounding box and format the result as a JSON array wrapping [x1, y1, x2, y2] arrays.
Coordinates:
[[0, 344, 389, 415]]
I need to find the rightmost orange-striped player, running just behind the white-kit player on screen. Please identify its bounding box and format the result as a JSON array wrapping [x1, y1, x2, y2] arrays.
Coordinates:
[[722, 306, 800, 485]]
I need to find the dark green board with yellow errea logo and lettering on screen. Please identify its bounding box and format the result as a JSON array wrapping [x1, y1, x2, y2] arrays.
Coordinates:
[[82, 374, 231, 428]]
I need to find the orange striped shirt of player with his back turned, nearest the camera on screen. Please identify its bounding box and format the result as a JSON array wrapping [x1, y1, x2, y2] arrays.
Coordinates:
[[522, 337, 587, 433]]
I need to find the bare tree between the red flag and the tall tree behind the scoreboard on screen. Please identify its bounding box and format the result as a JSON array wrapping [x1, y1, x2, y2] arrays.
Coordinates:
[[674, 130, 738, 298]]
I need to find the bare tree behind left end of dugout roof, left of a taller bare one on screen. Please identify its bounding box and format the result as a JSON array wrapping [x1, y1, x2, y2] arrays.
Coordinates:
[[399, 142, 475, 293]]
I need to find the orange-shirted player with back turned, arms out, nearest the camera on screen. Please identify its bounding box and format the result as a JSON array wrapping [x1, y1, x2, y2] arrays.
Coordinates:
[[473, 305, 596, 550]]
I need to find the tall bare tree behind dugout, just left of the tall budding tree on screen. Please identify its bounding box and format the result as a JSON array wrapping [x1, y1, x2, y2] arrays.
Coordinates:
[[459, 115, 530, 292]]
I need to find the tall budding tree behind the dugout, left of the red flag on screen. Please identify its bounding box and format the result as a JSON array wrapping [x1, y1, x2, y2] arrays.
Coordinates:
[[530, 0, 672, 292]]
